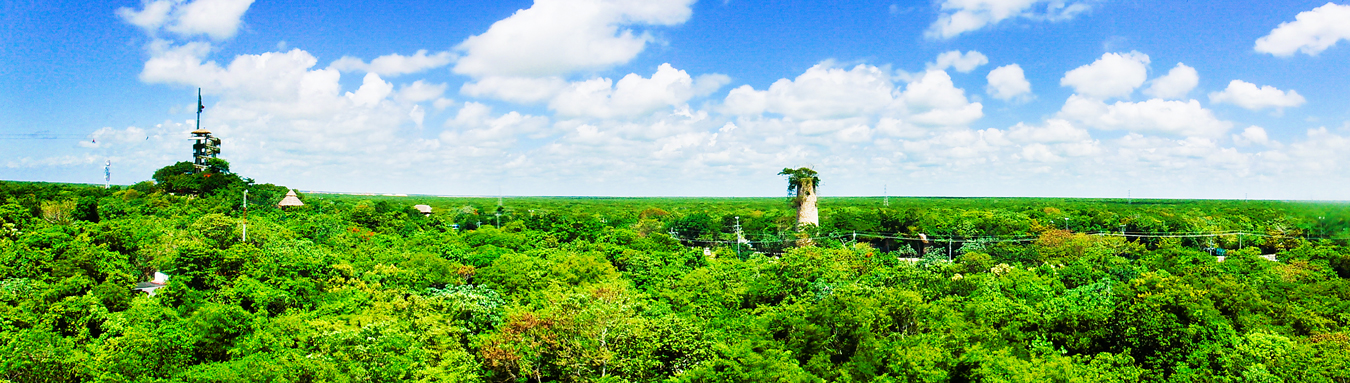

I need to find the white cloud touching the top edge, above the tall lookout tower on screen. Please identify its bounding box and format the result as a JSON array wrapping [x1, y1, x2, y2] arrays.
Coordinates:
[[116, 0, 254, 40]]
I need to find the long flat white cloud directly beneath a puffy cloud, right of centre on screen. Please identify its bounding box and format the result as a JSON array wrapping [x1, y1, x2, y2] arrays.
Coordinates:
[[1058, 94, 1233, 138]]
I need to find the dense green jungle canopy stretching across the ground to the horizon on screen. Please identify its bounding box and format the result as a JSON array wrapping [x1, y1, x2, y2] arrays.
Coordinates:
[[0, 160, 1350, 383]]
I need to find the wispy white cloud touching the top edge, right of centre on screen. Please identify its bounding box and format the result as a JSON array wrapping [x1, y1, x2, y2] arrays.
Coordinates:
[[925, 0, 1089, 39]]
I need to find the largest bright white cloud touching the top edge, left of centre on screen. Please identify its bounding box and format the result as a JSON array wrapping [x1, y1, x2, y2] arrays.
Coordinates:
[[454, 0, 693, 77]]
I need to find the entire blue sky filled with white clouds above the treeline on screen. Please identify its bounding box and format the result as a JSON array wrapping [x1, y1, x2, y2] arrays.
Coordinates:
[[0, 0, 1350, 200]]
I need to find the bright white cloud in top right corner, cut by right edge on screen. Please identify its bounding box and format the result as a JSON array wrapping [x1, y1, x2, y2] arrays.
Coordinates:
[[1256, 3, 1350, 57]]
